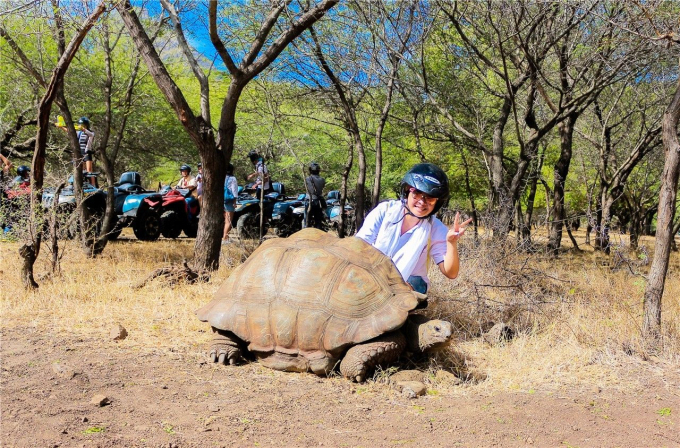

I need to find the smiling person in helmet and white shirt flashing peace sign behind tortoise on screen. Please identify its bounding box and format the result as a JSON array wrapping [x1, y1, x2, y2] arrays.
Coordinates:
[[356, 163, 472, 294]]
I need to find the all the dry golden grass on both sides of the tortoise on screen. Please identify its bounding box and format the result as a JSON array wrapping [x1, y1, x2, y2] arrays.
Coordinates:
[[0, 230, 680, 393]]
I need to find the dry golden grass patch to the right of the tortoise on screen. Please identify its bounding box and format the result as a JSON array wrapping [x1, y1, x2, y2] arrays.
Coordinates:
[[432, 232, 680, 391]]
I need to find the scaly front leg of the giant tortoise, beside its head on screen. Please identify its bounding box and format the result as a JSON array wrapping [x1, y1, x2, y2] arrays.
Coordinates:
[[340, 332, 406, 382]]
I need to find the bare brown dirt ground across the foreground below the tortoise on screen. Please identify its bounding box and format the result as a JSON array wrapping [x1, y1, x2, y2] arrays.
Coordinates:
[[0, 327, 680, 447]]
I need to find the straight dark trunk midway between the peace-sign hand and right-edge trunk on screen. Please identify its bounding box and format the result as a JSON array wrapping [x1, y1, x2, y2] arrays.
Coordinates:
[[548, 114, 577, 257]]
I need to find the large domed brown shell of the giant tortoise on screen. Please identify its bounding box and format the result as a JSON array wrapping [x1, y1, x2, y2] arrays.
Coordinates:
[[196, 228, 418, 358]]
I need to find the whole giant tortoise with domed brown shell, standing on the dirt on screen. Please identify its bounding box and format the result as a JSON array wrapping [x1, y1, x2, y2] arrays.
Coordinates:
[[196, 228, 451, 381]]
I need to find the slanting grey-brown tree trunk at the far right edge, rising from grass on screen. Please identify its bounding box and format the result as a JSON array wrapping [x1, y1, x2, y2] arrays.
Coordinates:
[[642, 82, 680, 337]]
